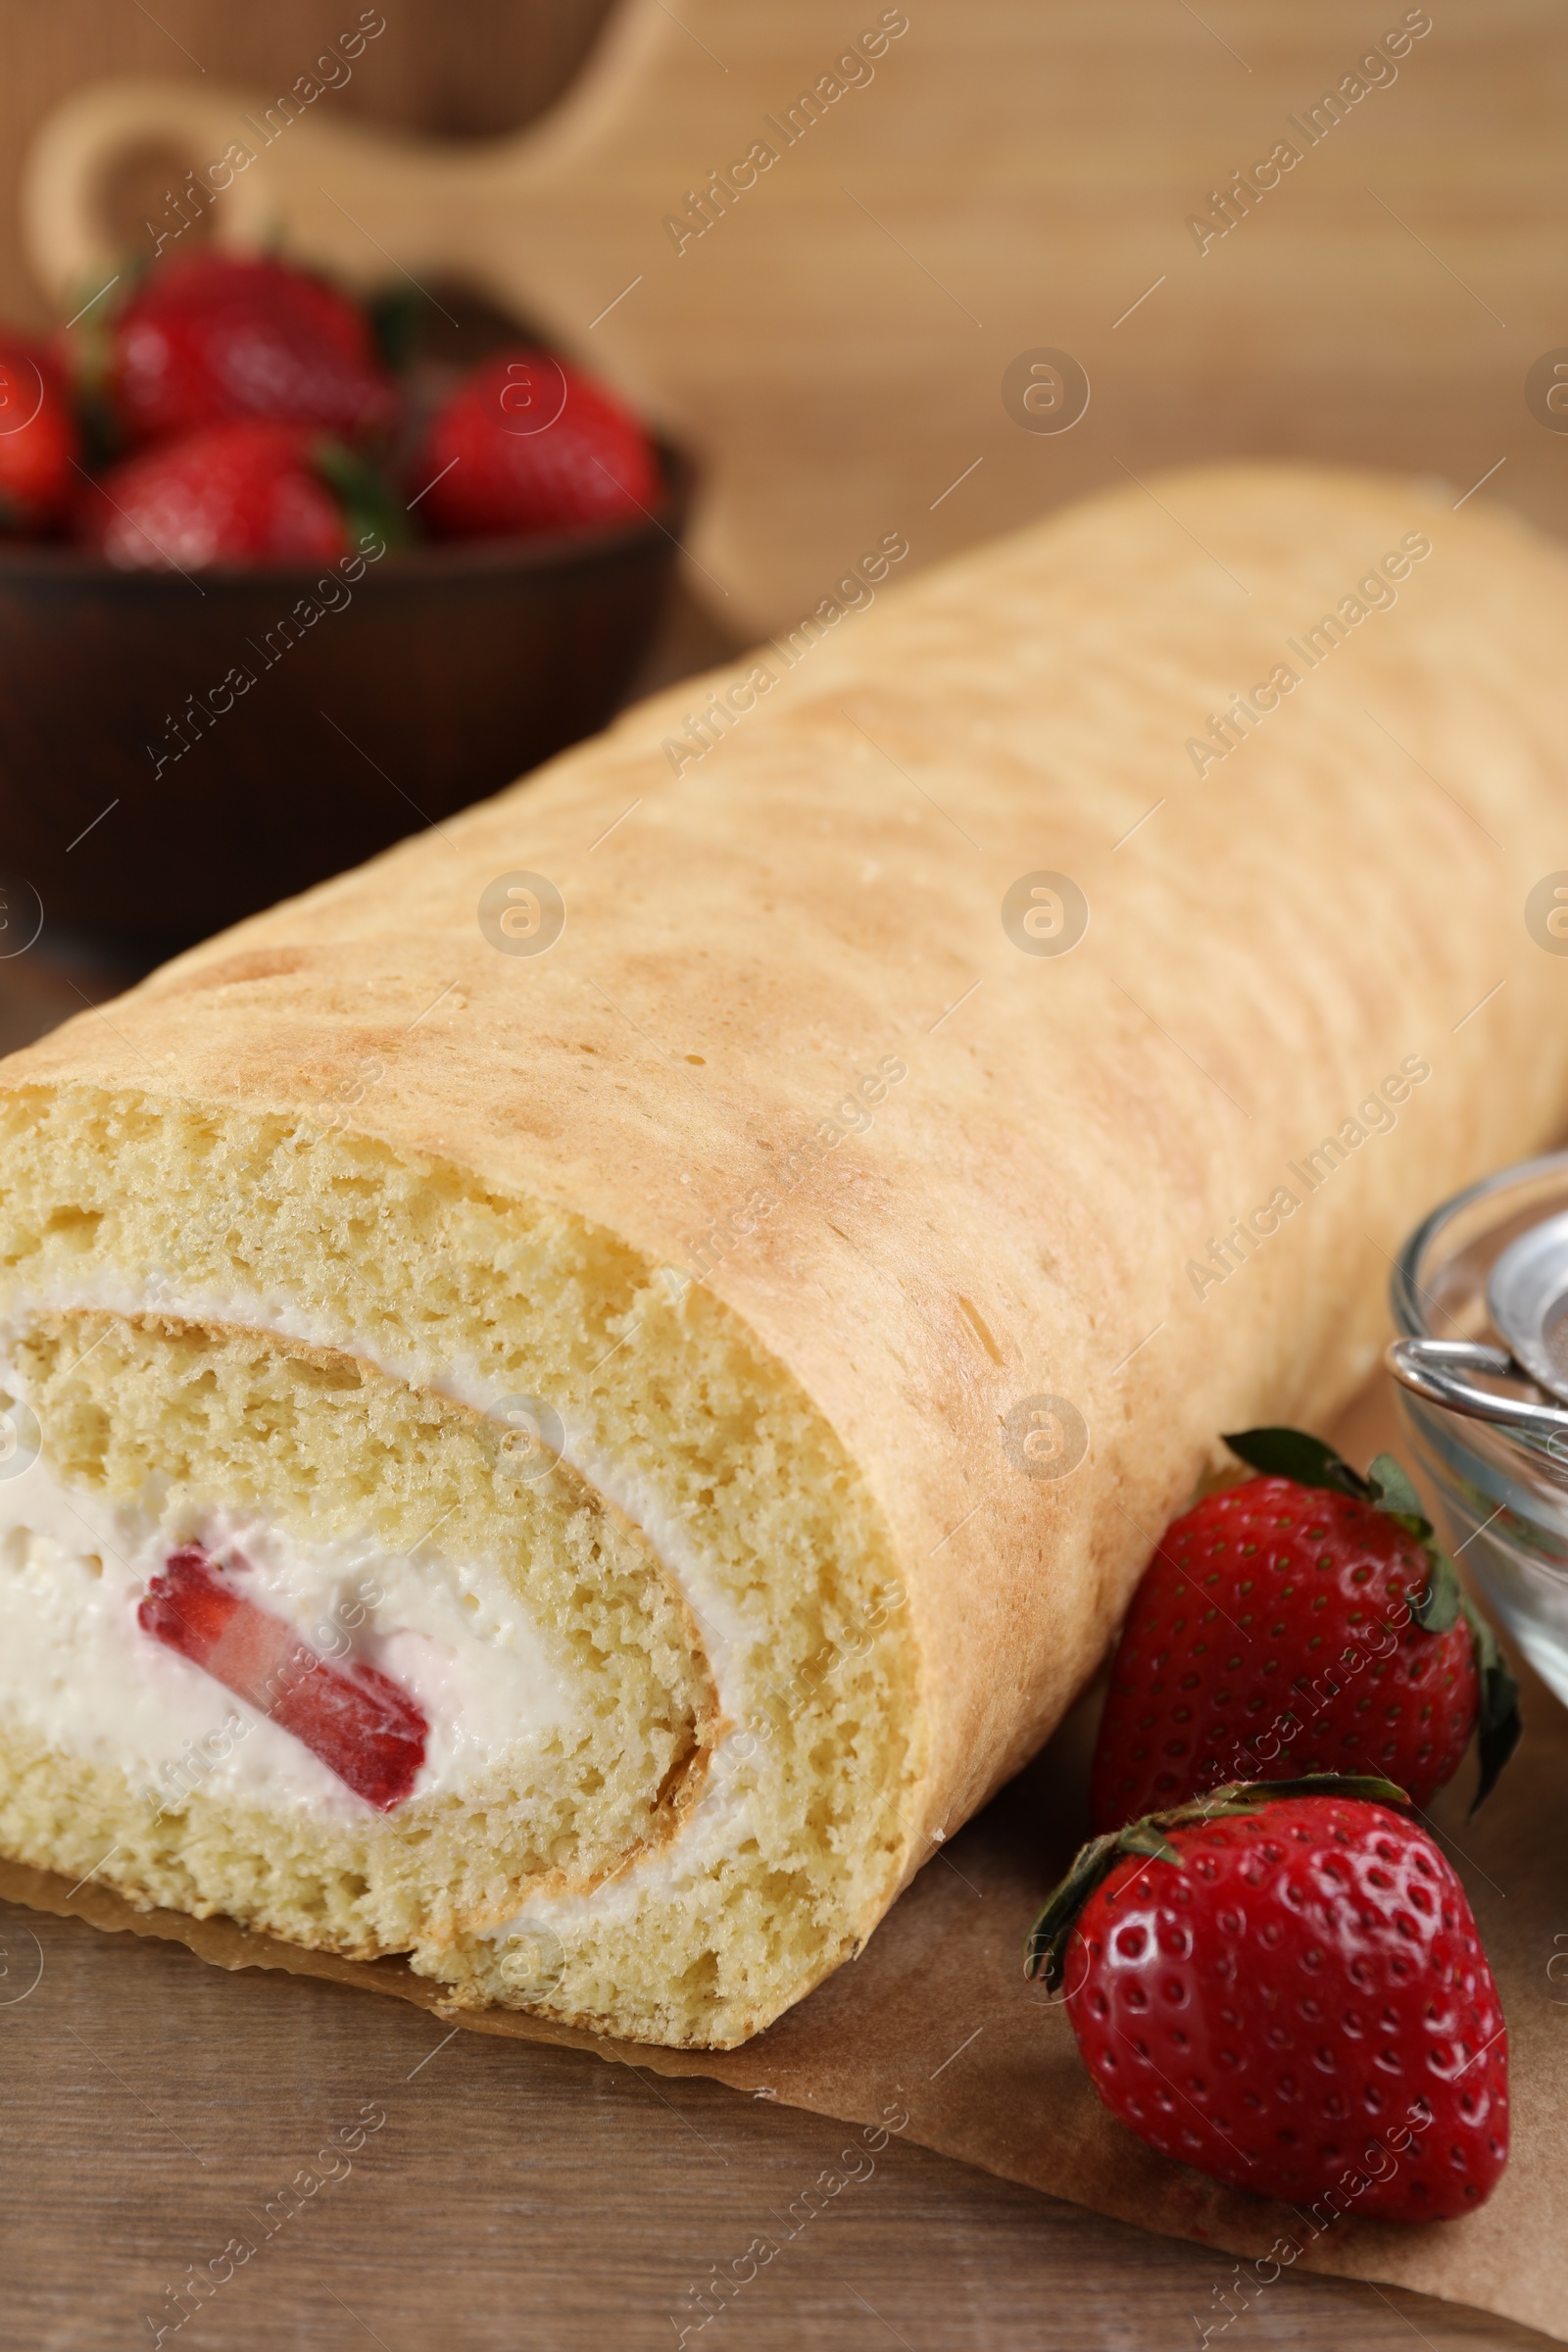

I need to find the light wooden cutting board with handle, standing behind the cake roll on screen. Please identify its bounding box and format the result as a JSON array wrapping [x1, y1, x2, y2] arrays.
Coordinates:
[[24, 0, 1568, 635]]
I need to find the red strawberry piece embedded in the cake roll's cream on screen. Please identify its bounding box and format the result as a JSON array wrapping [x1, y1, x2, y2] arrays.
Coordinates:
[[136, 1543, 430, 1813]]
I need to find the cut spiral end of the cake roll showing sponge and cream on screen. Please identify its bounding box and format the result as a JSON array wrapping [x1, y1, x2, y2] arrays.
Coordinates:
[[0, 1099, 909, 2039]]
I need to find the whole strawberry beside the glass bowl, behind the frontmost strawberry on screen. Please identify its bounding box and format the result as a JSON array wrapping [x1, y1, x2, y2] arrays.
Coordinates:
[[1089, 1430, 1519, 1830]]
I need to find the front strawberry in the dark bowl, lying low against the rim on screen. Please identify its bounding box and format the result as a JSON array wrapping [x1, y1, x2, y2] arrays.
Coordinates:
[[77, 423, 407, 571]]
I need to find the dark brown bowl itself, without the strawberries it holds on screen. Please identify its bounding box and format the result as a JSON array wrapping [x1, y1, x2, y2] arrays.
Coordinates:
[[0, 449, 691, 951]]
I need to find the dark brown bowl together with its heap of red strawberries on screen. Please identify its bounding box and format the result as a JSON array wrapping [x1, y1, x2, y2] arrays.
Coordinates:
[[0, 249, 691, 936]]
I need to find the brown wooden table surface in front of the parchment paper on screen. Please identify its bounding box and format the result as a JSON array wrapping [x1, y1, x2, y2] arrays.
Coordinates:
[[0, 602, 1544, 2352]]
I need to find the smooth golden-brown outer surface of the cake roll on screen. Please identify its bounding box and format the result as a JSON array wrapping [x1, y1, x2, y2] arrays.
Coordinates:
[[0, 468, 1568, 1966]]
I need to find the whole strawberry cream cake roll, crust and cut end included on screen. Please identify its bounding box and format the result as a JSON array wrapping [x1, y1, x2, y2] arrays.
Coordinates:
[[0, 468, 1568, 2046]]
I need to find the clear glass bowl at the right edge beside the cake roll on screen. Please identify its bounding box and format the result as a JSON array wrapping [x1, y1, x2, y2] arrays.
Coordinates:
[[1390, 1152, 1568, 1705]]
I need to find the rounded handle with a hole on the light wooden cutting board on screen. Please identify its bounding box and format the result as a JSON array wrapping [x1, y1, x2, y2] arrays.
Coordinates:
[[22, 77, 508, 311]]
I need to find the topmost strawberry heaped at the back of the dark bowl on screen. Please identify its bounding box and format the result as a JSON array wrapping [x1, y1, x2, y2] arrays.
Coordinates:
[[85, 252, 393, 442]]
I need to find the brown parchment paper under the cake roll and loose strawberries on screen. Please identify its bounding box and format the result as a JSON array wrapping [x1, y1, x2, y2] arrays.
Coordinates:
[[0, 1383, 1568, 2342]]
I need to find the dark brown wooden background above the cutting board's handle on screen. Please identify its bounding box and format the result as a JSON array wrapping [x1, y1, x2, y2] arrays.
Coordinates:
[[0, 0, 613, 324]]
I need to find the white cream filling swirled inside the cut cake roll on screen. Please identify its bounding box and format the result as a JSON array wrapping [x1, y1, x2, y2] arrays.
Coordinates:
[[0, 1272, 757, 1940]]
